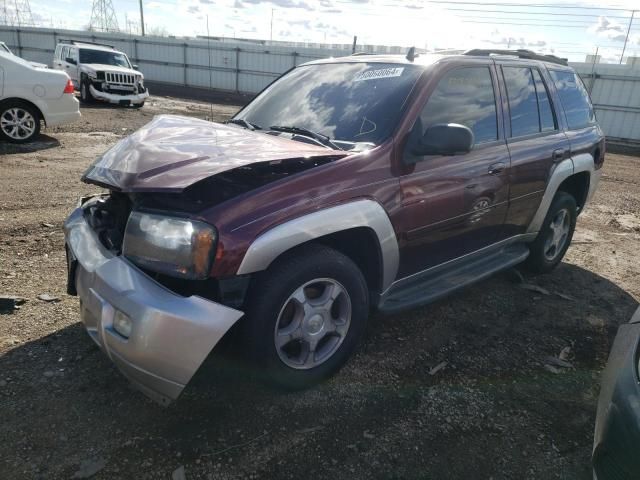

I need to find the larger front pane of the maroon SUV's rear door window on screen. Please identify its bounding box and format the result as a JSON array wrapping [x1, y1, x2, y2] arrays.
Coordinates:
[[502, 67, 540, 137]]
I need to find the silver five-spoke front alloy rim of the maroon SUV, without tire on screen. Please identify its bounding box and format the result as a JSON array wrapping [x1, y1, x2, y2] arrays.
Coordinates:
[[274, 278, 351, 370]]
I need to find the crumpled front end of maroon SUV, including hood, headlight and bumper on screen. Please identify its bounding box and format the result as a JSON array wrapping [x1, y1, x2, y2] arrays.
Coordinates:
[[64, 117, 344, 404]]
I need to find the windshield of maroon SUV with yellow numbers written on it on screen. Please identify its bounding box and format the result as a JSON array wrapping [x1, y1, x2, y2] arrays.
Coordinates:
[[236, 63, 422, 145]]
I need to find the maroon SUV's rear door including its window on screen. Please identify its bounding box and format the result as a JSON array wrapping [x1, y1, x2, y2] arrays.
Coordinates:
[[497, 61, 571, 236]]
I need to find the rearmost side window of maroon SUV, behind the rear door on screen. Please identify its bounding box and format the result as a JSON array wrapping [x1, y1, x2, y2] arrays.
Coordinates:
[[549, 70, 595, 130]]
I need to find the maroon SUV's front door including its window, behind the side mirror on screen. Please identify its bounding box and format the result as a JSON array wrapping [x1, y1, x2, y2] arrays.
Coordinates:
[[399, 60, 510, 277]]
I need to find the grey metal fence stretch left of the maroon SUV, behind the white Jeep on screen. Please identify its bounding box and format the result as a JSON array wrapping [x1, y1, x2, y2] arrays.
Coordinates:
[[0, 26, 350, 93]]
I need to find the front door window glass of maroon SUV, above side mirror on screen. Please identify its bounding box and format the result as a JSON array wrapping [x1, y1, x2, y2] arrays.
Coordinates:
[[420, 67, 498, 144]]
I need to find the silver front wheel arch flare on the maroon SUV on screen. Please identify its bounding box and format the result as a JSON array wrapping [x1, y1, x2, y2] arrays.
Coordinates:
[[237, 199, 399, 291]]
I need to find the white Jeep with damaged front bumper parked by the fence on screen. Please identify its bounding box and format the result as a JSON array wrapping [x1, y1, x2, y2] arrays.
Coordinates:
[[53, 40, 149, 108]]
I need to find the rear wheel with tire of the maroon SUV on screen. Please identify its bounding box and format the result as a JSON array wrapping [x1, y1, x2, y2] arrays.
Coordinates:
[[525, 192, 577, 273]]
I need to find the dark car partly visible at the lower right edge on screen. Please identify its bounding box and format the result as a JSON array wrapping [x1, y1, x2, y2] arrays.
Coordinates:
[[593, 308, 640, 480]]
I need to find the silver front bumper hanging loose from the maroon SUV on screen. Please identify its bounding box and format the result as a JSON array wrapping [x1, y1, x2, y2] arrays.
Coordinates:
[[64, 208, 243, 404]]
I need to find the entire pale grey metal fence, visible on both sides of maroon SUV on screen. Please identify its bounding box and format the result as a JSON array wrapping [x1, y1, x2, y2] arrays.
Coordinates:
[[0, 26, 640, 146]]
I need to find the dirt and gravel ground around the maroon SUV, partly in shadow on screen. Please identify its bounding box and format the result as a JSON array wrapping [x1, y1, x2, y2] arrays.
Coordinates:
[[0, 97, 640, 480]]
